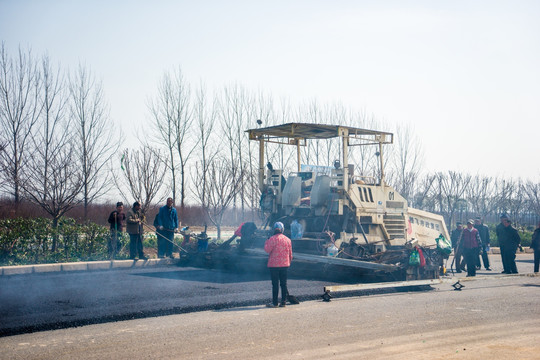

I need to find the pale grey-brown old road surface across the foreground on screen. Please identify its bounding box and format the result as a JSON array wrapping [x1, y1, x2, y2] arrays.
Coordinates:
[[0, 275, 540, 360]]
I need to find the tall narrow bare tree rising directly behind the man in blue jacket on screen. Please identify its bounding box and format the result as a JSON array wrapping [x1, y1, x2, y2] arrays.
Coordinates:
[[149, 69, 195, 211]]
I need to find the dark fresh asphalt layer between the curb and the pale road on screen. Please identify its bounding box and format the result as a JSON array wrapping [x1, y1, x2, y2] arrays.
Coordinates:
[[0, 250, 532, 336]]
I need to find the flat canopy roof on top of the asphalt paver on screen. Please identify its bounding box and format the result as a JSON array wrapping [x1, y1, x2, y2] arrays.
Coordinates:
[[247, 123, 393, 143]]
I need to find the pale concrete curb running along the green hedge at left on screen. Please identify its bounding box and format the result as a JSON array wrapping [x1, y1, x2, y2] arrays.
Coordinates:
[[0, 259, 178, 276]]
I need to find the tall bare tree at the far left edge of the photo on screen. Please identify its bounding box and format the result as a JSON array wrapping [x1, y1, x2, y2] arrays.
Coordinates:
[[0, 43, 41, 204]]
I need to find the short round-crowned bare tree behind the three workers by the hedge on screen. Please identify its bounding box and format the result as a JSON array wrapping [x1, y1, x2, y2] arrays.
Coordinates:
[[115, 145, 167, 213]]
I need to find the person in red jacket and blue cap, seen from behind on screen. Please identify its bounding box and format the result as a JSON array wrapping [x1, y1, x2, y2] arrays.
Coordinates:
[[264, 221, 292, 308]]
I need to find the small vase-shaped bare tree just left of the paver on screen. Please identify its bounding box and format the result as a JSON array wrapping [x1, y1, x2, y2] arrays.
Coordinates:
[[195, 158, 245, 239]]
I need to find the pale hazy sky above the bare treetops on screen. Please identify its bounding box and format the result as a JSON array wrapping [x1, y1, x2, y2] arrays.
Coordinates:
[[0, 0, 540, 181]]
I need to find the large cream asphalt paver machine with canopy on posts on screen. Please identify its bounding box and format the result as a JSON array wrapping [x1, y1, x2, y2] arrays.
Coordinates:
[[244, 123, 449, 280]]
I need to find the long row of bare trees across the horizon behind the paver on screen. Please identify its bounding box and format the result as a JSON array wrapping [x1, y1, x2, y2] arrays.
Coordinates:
[[0, 44, 540, 236]]
